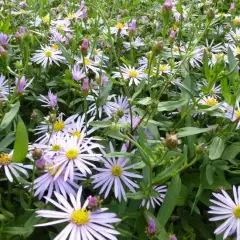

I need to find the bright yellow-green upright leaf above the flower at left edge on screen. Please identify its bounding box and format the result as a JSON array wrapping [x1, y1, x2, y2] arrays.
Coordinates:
[[12, 122, 28, 162]]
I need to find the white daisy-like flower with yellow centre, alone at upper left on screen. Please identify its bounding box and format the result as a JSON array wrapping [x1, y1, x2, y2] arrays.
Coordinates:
[[31, 46, 65, 68]]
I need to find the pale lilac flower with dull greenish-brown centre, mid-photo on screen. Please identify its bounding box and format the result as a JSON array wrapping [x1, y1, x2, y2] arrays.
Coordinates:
[[104, 95, 134, 122]]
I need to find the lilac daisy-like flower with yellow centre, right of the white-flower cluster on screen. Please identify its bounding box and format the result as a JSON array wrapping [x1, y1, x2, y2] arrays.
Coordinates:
[[91, 142, 142, 201]]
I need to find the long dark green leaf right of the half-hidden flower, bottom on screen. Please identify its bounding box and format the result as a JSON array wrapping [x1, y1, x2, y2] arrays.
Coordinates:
[[157, 175, 181, 227]]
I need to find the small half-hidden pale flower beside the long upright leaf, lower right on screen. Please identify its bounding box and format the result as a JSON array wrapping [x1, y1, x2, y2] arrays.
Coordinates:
[[141, 186, 167, 209]]
